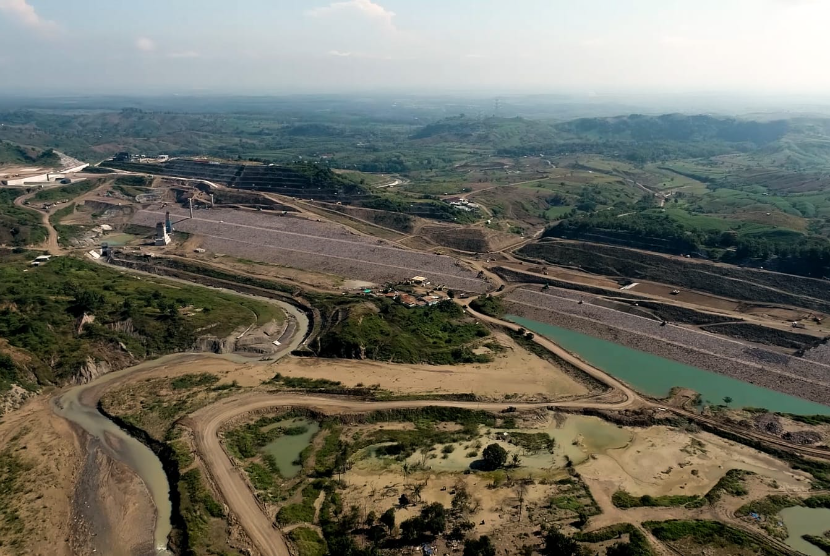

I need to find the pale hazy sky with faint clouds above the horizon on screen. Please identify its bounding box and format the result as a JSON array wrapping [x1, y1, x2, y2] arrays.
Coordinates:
[[0, 0, 830, 96]]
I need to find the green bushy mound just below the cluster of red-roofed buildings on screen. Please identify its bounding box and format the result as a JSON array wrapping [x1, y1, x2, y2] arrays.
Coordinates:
[[319, 299, 491, 365]]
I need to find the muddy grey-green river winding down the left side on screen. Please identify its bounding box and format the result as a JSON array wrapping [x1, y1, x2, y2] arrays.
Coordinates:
[[52, 300, 308, 554]]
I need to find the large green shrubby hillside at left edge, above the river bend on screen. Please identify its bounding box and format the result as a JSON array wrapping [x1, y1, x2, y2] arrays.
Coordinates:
[[0, 253, 275, 390]]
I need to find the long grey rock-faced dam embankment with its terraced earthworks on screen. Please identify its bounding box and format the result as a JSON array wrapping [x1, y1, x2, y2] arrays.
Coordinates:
[[27, 156, 830, 404]]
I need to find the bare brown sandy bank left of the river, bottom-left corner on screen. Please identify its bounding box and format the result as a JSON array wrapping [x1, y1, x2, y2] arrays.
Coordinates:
[[0, 396, 155, 556]]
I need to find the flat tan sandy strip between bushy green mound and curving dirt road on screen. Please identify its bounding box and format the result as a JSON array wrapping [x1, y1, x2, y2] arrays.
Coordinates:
[[273, 333, 589, 401]]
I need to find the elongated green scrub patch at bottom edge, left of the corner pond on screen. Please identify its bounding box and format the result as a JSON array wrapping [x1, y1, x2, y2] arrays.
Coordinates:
[[643, 520, 782, 556]]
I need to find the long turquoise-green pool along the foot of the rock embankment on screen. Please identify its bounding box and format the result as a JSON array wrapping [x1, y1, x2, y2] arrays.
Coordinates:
[[507, 315, 830, 415]]
